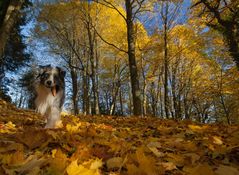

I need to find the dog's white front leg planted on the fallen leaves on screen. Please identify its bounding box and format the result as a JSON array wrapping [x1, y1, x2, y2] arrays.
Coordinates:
[[45, 106, 61, 128]]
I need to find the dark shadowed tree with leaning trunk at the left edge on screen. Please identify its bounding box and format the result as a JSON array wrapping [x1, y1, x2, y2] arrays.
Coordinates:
[[0, 1, 30, 101]]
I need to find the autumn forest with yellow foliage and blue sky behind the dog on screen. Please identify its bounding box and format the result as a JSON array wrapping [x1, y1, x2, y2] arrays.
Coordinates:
[[0, 0, 239, 124]]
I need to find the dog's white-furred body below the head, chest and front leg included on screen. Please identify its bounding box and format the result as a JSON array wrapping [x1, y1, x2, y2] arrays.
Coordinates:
[[35, 84, 63, 128]]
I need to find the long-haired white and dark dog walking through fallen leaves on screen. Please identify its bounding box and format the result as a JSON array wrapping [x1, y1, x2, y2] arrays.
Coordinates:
[[34, 65, 66, 128]]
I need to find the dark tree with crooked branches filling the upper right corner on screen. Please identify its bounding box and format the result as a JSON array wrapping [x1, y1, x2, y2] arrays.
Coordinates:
[[191, 0, 239, 69]]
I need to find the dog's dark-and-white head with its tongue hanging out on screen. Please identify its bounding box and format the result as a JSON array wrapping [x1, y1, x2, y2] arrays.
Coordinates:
[[38, 65, 66, 96]]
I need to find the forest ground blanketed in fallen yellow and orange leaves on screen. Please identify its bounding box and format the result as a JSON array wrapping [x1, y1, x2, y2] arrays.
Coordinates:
[[0, 101, 239, 175]]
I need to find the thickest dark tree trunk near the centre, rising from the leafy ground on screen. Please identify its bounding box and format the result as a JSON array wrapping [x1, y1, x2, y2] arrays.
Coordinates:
[[125, 0, 142, 116]]
